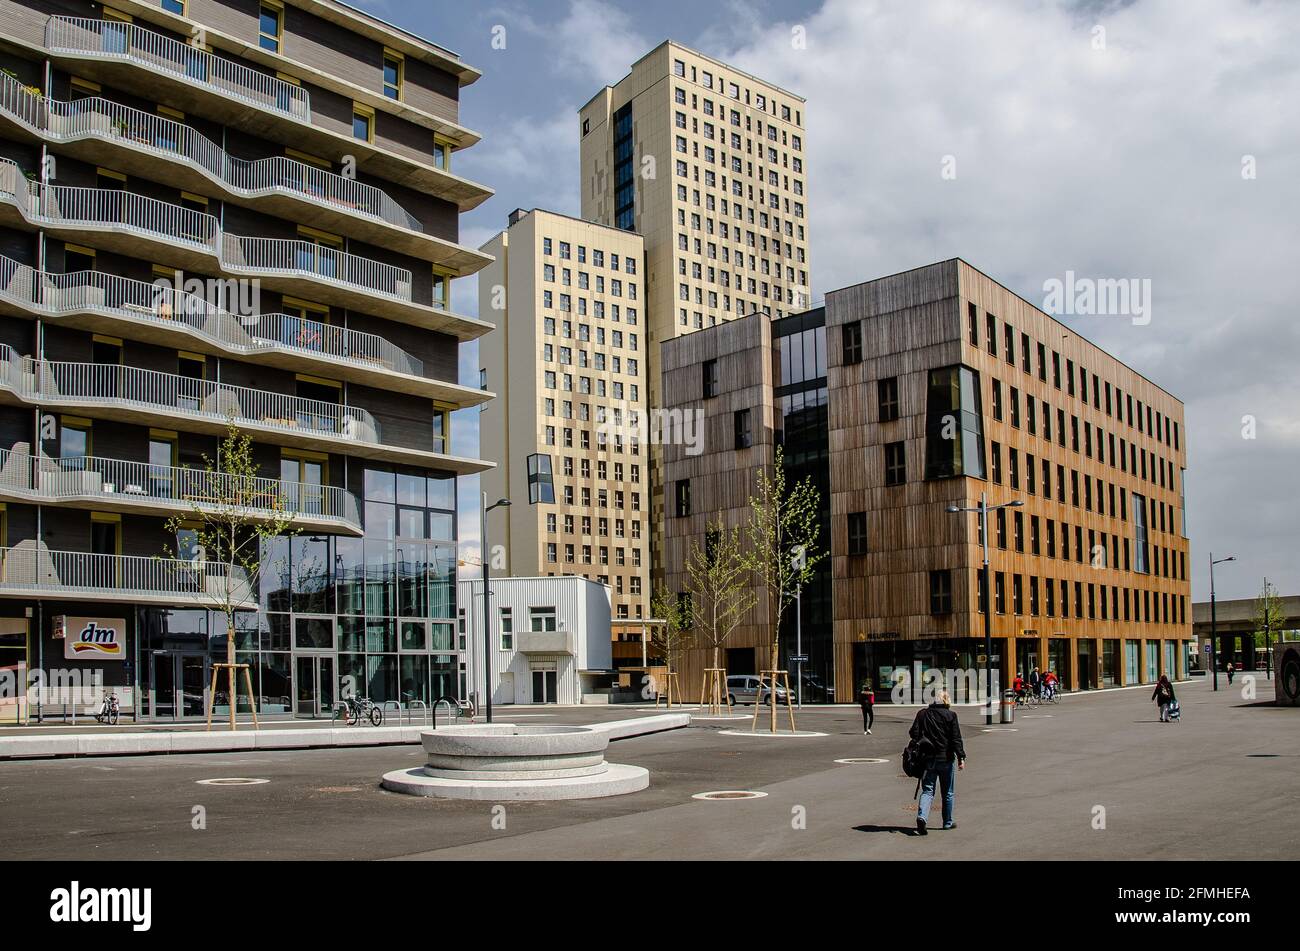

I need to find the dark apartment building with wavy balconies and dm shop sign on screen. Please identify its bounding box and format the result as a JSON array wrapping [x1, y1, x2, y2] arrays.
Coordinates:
[[0, 0, 491, 720]]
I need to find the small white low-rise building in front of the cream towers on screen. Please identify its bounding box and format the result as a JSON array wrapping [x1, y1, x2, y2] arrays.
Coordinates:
[[456, 576, 612, 705]]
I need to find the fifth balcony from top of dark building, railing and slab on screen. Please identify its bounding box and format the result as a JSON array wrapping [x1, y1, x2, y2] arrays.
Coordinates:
[[0, 346, 489, 474]]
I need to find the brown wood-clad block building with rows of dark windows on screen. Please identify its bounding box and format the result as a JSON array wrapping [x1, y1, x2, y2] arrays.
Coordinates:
[[664, 260, 1195, 699]]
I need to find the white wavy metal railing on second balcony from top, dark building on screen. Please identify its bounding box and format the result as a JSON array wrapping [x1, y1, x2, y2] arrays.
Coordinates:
[[0, 74, 424, 233]]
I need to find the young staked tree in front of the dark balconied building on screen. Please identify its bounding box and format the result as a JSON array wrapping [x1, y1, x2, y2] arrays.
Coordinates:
[[166, 420, 295, 730]]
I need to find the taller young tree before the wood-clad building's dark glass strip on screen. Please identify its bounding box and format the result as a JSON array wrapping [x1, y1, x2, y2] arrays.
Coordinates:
[[746, 446, 826, 731]]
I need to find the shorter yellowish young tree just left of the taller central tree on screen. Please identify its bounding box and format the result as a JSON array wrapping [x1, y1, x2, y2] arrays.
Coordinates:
[[686, 516, 758, 708]]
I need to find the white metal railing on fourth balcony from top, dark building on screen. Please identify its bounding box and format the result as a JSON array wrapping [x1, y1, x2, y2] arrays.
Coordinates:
[[0, 255, 424, 377]]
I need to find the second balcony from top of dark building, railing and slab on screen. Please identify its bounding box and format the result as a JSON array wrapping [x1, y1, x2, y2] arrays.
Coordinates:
[[0, 75, 491, 275]]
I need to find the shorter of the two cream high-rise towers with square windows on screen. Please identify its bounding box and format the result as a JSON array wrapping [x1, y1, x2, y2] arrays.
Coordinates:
[[478, 209, 650, 618]]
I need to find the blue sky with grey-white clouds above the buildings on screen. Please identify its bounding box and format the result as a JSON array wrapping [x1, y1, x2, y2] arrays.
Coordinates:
[[356, 0, 1300, 600]]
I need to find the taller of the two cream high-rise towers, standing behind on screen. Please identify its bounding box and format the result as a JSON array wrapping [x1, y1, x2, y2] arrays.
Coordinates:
[[579, 42, 811, 579]]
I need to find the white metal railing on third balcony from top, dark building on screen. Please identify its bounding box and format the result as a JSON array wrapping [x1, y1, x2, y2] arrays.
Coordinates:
[[0, 159, 412, 301]]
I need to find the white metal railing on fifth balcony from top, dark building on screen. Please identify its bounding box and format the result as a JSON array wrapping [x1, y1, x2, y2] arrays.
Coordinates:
[[0, 346, 380, 443]]
